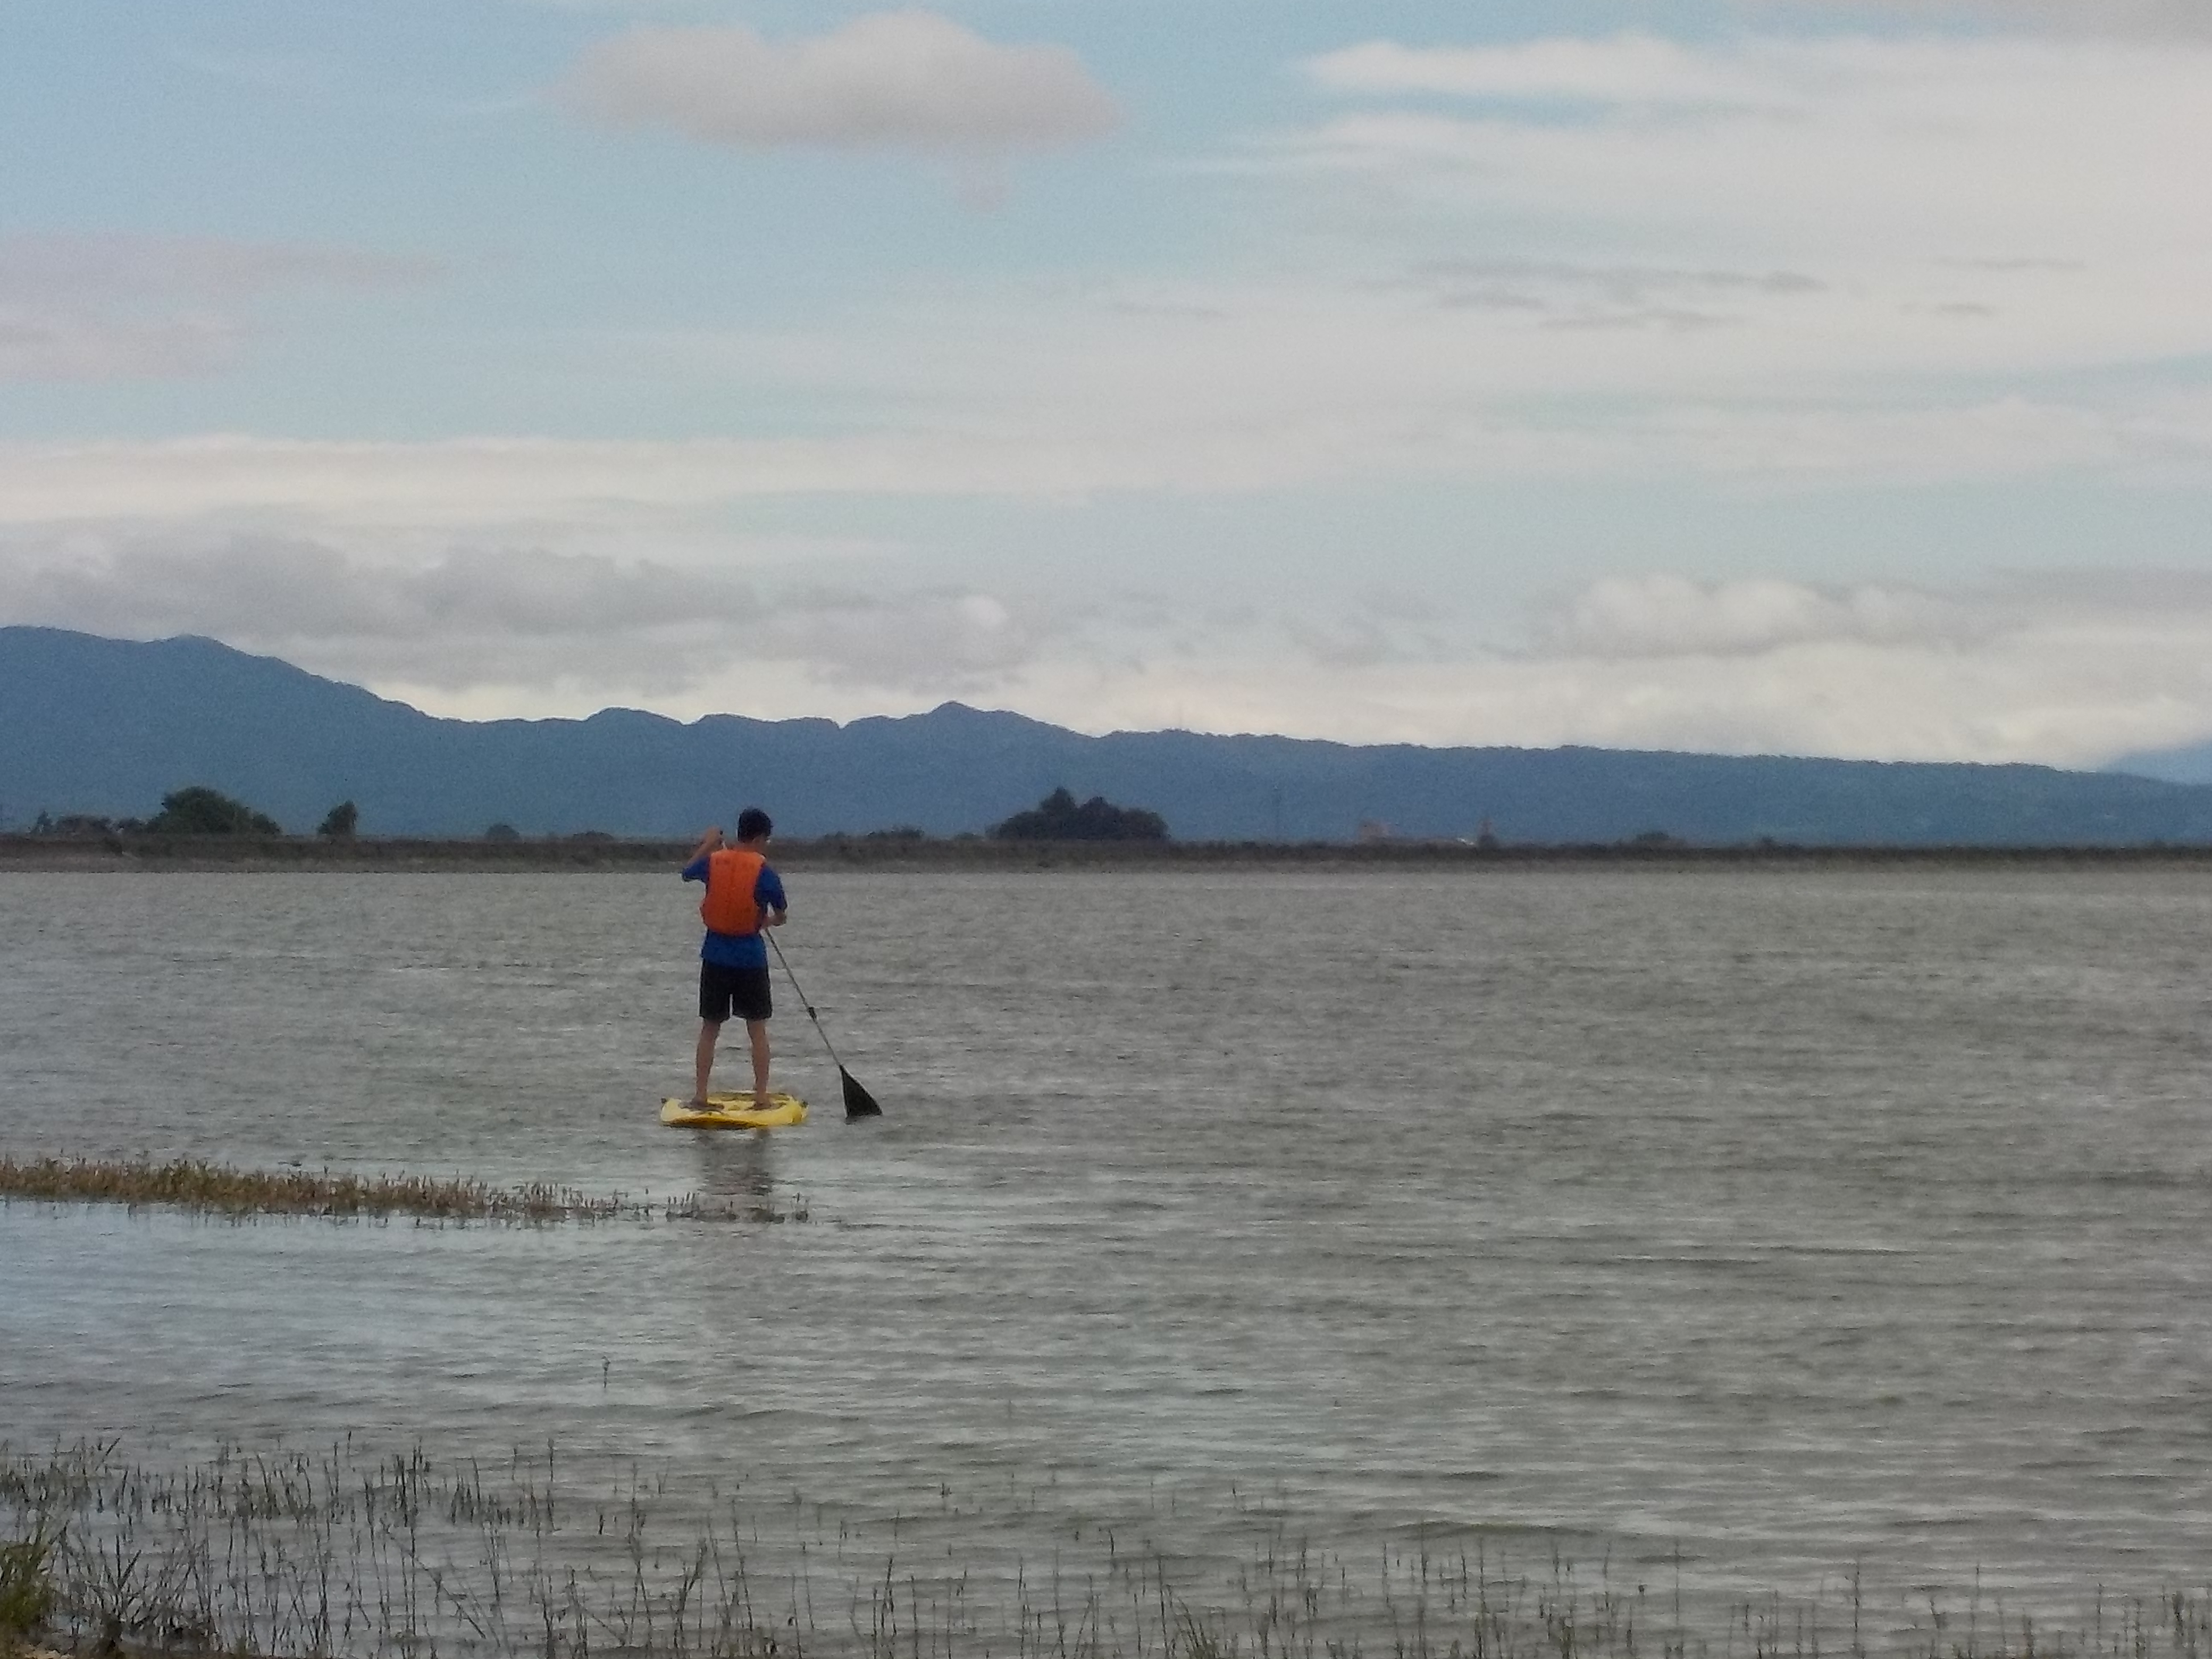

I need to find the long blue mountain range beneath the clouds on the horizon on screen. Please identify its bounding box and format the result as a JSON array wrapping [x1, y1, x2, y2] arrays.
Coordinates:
[[0, 628, 2212, 847]]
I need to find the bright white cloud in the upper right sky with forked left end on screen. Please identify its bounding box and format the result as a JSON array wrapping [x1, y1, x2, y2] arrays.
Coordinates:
[[1294, 36, 2212, 271]]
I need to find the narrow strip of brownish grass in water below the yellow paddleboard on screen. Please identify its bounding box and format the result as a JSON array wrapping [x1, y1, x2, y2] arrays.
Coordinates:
[[0, 1157, 807, 1226]]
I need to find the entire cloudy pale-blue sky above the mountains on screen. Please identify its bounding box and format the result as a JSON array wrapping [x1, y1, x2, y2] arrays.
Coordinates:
[[0, 0, 2212, 763]]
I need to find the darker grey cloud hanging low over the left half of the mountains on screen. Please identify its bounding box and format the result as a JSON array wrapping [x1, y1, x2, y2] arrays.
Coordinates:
[[0, 531, 1068, 708]]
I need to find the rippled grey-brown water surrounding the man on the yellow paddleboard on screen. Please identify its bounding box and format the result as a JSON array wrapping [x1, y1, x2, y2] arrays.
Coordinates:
[[0, 869, 2212, 1646]]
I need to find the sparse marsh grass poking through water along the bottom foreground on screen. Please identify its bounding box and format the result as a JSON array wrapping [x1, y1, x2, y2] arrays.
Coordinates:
[[0, 1442, 2212, 1659]]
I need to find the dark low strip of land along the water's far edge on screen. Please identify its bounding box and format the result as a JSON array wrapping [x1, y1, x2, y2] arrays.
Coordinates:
[[0, 834, 2212, 874]]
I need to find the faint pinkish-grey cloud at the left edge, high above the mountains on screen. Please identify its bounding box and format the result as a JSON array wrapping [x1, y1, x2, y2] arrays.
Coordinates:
[[0, 234, 438, 381]]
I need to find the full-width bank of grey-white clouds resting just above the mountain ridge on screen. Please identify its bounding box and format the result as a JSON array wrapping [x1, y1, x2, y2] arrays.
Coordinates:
[[13, 529, 2212, 765]]
